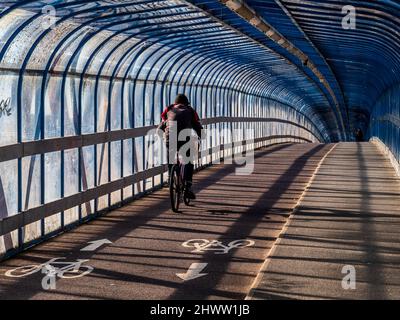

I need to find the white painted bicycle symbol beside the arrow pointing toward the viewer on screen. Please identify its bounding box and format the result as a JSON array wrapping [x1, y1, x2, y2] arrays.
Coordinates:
[[182, 239, 255, 254]]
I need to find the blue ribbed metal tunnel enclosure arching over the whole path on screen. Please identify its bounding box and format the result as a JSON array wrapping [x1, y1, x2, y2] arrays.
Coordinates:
[[0, 0, 400, 254]]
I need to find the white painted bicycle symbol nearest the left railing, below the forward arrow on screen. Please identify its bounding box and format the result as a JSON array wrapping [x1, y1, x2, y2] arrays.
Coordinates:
[[5, 257, 94, 279]]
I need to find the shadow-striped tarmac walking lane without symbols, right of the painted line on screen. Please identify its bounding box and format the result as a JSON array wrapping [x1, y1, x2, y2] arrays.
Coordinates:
[[250, 143, 400, 300]]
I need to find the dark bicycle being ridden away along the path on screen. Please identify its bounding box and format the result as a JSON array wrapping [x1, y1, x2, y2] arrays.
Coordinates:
[[169, 152, 190, 213]]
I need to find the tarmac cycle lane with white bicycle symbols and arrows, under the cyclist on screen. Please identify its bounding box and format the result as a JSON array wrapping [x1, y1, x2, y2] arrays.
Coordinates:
[[0, 144, 332, 300]]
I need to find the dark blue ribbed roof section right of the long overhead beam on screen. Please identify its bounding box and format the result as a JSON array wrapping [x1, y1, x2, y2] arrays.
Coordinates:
[[264, 0, 400, 135]]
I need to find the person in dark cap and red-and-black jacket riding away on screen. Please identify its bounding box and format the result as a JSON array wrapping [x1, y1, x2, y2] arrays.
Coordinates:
[[158, 94, 203, 200]]
